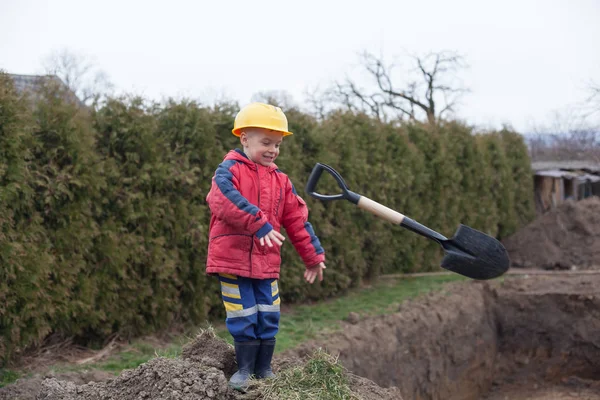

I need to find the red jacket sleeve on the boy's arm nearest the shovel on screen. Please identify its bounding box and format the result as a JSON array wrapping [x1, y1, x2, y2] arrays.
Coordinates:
[[282, 178, 325, 268]]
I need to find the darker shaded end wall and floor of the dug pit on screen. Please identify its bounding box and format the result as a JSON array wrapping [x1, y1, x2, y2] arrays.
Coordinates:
[[485, 274, 600, 400]]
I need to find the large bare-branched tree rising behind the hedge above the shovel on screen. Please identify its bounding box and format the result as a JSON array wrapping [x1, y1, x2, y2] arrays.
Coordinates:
[[331, 51, 467, 124]]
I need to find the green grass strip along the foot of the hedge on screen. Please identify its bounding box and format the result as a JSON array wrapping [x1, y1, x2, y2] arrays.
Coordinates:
[[0, 275, 466, 387]]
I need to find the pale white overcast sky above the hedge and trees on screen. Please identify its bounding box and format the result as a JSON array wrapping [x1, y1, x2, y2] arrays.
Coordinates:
[[0, 0, 600, 132]]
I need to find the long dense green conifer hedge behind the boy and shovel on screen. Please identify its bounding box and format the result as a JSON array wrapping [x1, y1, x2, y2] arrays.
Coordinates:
[[0, 74, 534, 364]]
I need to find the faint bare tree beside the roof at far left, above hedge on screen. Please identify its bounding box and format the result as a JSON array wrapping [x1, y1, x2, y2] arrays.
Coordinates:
[[42, 49, 113, 104]]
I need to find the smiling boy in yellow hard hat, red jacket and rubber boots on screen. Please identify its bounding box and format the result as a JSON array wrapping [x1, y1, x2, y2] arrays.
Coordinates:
[[206, 103, 325, 391]]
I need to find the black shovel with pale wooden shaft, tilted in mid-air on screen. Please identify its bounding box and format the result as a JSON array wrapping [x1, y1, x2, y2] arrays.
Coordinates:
[[306, 163, 510, 280]]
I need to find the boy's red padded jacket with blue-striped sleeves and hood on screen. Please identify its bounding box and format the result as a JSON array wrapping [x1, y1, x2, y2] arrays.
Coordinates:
[[206, 149, 325, 279]]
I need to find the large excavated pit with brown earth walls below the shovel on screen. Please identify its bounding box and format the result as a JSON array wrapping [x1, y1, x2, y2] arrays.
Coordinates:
[[294, 276, 600, 400]]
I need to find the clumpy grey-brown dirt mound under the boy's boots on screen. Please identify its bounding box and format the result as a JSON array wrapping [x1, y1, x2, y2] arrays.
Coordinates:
[[0, 331, 401, 400]]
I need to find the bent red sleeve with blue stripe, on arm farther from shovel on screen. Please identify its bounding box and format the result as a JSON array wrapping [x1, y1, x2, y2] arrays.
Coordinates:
[[206, 160, 273, 238]]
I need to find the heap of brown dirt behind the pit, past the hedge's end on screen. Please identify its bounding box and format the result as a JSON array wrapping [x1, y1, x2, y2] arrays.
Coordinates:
[[503, 196, 600, 269]]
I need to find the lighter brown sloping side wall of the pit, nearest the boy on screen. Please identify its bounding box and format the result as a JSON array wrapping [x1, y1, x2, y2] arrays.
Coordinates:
[[291, 283, 497, 400]]
